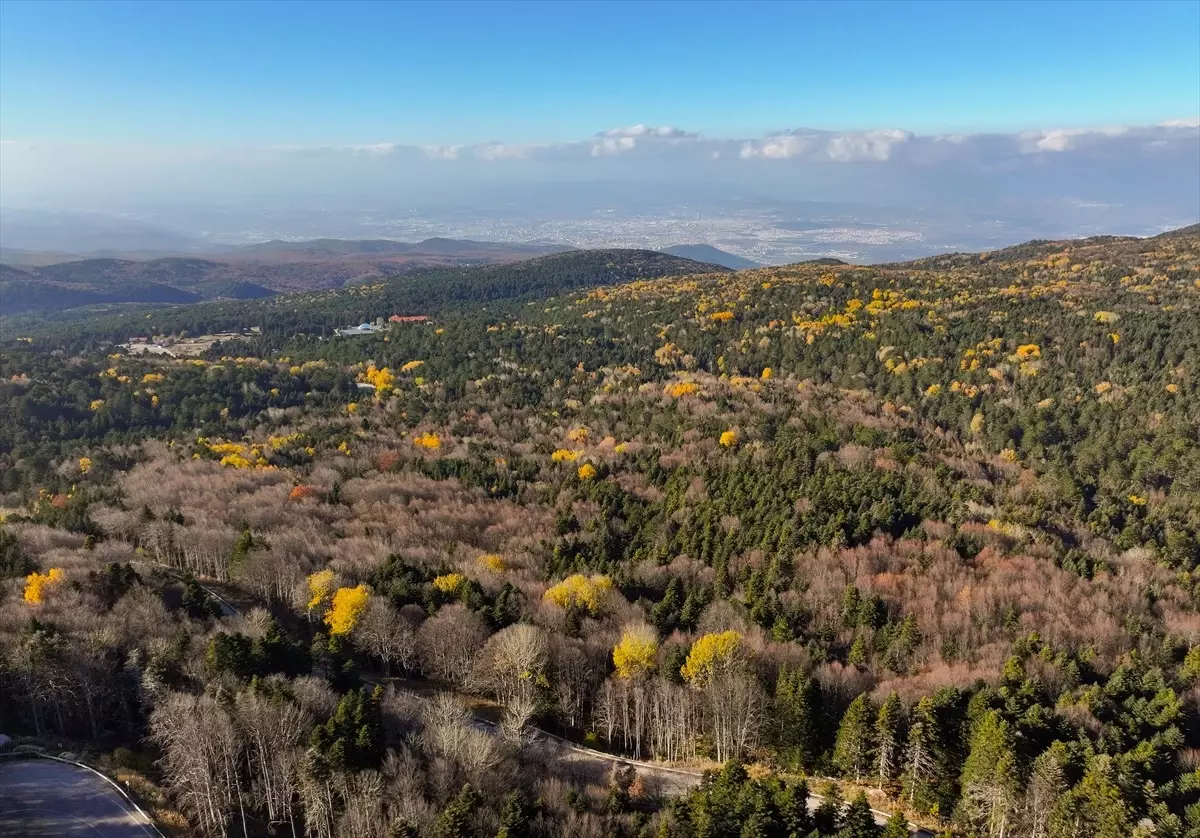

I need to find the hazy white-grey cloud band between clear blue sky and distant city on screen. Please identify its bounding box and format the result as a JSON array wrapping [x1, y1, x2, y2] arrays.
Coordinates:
[[0, 118, 1200, 215]]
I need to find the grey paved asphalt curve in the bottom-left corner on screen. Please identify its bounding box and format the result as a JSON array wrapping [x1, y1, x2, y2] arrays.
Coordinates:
[[0, 759, 160, 838]]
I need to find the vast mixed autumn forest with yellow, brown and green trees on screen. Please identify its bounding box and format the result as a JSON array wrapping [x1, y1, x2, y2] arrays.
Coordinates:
[[0, 229, 1200, 838]]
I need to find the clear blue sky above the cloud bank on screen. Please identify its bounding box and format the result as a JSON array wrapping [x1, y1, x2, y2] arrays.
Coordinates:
[[0, 0, 1200, 146]]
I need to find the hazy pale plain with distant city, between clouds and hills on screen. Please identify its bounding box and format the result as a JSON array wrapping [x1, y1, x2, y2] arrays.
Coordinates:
[[0, 197, 1196, 264]]
